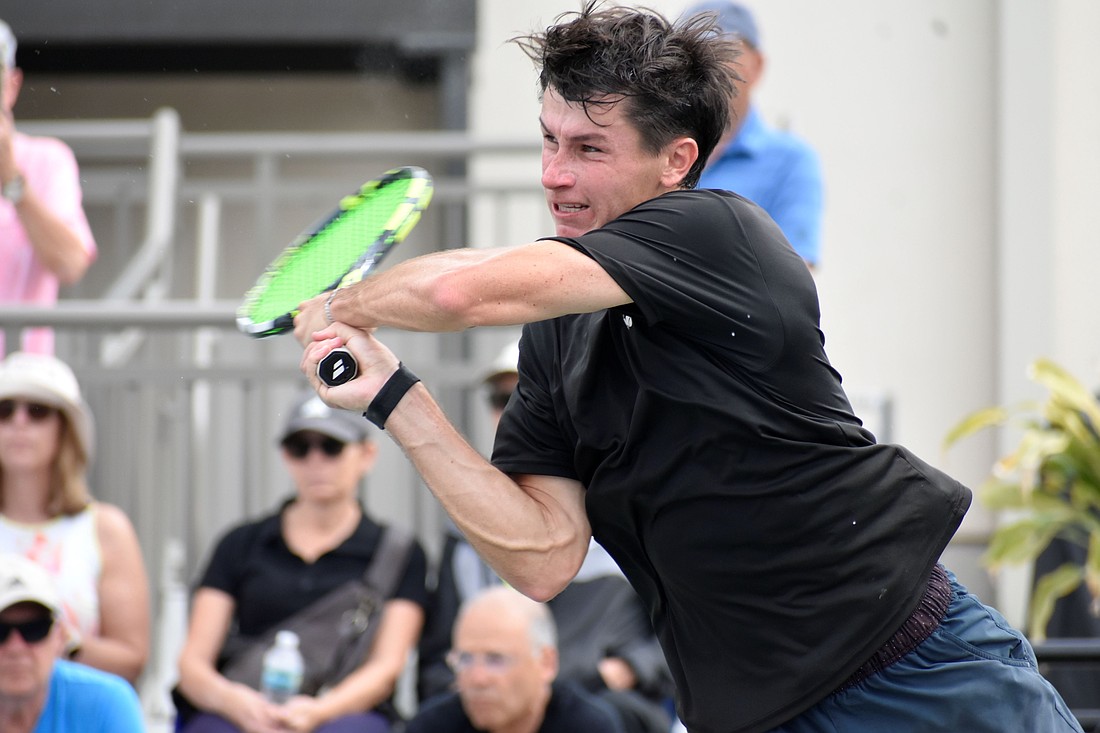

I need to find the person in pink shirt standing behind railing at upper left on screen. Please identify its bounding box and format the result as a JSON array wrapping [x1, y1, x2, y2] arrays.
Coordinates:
[[0, 20, 96, 355]]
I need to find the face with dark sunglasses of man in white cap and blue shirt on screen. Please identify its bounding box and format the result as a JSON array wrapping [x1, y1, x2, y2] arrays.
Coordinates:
[[0, 603, 64, 703]]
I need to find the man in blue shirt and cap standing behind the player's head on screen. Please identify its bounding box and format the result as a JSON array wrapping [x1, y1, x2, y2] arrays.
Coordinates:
[[686, 0, 822, 266]]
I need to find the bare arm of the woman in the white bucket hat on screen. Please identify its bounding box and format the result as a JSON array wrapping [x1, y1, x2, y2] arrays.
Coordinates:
[[76, 504, 150, 682]]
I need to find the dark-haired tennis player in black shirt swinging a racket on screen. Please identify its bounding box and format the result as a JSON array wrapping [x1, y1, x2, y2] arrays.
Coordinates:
[[296, 2, 1081, 733]]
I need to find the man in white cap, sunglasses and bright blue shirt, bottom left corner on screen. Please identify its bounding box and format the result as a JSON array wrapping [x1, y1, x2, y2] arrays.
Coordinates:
[[0, 554, 145, 733]]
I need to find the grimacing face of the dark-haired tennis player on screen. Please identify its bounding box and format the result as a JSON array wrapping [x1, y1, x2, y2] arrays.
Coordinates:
[[539, 88, 683, 237]]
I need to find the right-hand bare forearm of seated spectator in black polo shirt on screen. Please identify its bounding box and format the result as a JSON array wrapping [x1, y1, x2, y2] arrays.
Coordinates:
[[278, 599, 424, 733]]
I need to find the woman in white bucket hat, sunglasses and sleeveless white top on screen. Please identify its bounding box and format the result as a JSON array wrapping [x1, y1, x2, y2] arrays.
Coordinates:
[[0, 352, 150, 681]]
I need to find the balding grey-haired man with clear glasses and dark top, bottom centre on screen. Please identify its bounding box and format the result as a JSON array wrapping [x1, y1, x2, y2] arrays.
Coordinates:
[[406, 586, 623, 733]]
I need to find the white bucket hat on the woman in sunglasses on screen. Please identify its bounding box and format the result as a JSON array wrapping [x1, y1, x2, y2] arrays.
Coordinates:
[[0, 351, 96, 462]]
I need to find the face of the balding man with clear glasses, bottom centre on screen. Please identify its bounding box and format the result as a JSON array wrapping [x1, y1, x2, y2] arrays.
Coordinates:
[[449, 609, 558, 733]]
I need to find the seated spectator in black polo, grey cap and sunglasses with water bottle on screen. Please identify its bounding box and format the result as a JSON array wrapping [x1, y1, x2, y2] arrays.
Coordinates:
[[177, 394, 427, 733]]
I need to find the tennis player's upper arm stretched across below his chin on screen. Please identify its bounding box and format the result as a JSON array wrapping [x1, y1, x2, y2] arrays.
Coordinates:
[[295, 241, 630, 344]]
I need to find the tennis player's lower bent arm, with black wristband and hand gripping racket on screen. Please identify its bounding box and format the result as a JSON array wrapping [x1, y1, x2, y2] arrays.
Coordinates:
[[303, 324, 592, 601]]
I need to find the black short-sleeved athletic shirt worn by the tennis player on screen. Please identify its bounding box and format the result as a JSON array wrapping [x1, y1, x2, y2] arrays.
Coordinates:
[[493, 190, 970, 733]]
